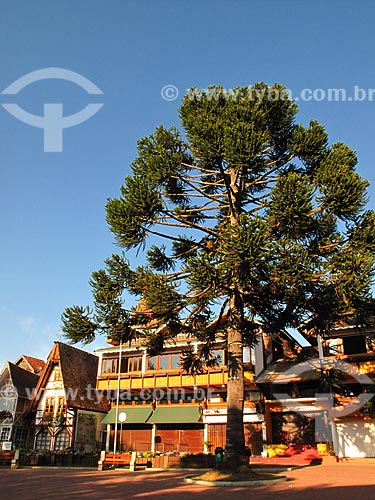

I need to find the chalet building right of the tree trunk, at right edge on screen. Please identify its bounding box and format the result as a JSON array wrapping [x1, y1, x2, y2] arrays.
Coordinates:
[[256, 327, 375, 458]]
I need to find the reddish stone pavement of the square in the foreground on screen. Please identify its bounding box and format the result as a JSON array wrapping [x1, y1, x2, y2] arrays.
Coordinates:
[[0, 463, 375, 500]]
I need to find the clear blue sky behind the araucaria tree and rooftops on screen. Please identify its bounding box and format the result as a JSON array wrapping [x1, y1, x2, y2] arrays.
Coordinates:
[[0, 0, 375, 366]]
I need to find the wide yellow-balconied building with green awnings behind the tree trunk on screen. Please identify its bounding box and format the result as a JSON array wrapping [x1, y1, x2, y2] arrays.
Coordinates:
[[96, 334, 263, 455]]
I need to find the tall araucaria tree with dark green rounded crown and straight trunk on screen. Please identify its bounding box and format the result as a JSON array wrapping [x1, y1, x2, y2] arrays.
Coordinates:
[[63, 83, 375, 468]]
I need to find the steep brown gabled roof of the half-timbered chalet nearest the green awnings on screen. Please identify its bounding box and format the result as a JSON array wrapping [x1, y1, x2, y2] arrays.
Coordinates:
[[32, 341, 108, 412]]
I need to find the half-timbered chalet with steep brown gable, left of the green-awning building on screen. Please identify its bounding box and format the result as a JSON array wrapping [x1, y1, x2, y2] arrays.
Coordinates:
[[30, 342, 108, 452]]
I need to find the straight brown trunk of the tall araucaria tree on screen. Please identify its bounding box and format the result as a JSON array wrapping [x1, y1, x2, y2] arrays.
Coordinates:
[[223, 297, 248, 470]]
